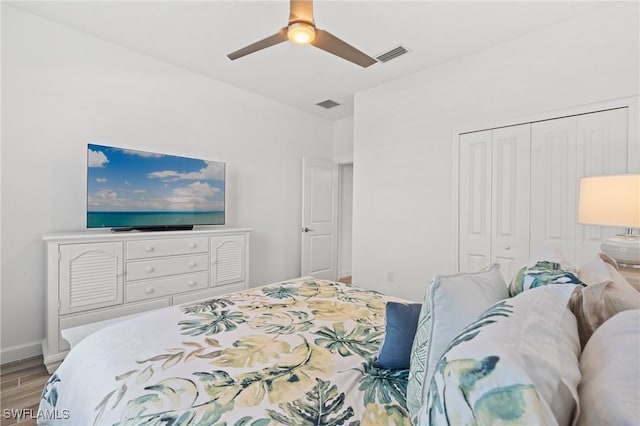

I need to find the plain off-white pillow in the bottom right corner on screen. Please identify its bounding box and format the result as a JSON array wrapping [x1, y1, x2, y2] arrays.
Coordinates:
[[578, 309, 640, 426]]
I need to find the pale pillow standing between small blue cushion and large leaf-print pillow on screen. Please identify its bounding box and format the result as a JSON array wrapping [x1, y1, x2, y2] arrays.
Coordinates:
[[407, 264, 508, 419]]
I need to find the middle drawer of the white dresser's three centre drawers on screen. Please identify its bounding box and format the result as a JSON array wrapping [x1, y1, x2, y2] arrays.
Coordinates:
[[125, 254, 209, 281]]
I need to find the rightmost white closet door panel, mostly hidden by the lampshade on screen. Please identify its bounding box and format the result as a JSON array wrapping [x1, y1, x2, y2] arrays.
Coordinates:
[[575, 108, 629, 265]]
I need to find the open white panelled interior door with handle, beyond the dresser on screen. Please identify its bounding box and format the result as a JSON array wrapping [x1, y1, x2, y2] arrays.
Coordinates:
[[301, 158, 338, 280]]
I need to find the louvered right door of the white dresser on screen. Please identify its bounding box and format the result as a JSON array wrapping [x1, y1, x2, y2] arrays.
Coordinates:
[[211, 235, 247, 287]]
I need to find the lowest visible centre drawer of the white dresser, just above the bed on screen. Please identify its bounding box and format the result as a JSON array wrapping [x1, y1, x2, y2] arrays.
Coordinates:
[[126, 272, 209, 303]]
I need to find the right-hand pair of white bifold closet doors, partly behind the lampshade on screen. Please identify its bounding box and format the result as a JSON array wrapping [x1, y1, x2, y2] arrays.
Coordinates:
[[531, 108, 629, 266]]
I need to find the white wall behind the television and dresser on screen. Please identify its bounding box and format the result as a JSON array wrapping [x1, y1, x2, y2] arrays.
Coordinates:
[[1, 4, 333, 362]]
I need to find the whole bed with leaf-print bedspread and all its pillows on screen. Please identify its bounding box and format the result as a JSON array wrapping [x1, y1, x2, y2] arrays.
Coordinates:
[[38, 252, 640, 426]]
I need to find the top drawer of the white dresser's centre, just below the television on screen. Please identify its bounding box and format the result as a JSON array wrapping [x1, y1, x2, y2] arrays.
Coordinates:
[[126, 237, 209, 259]]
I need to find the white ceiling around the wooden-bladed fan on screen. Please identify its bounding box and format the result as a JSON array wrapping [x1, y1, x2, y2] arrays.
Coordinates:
[[9, 0, 606, 120]]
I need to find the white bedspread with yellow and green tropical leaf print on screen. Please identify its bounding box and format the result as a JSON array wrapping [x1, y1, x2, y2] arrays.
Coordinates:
[[40, 279, 411, 426]]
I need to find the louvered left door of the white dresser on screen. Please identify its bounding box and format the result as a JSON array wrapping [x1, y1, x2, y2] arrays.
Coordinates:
[[59, 241, 124, 315]]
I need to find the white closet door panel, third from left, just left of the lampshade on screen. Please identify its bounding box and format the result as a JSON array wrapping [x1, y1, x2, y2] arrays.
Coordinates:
[[530, 117, 578, 260]]
